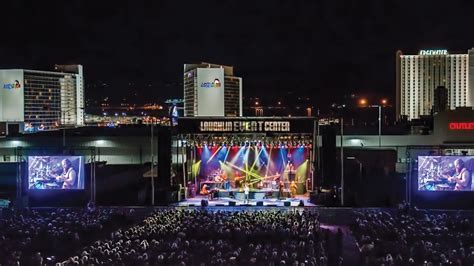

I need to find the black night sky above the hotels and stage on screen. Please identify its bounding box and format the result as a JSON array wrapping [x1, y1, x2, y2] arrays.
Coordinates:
[[0, 0, 474, 104]]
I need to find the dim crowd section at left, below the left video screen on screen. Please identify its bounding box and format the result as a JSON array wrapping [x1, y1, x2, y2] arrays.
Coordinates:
[[0, 208, 133, 265]]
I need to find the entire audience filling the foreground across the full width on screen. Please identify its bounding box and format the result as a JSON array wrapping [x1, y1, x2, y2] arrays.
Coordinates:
[[20, 204, 474, 266]]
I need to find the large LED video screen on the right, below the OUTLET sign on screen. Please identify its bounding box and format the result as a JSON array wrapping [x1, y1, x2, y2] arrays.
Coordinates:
[[418, 156, 474, 191]]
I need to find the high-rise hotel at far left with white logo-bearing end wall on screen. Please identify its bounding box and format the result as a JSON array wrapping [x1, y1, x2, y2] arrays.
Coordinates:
[[0, 65, 84, 132]]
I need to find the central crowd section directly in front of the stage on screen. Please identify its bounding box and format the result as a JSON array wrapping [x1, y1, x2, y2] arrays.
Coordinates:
[[63, 209, 331, 266]]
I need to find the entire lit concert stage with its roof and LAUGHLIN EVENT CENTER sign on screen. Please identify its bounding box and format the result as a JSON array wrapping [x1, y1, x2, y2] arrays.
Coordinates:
[[173, 117, 315, 206]]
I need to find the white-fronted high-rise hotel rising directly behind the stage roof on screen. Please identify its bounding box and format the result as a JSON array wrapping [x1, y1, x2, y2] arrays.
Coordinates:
[[183, 63, 242, 117]]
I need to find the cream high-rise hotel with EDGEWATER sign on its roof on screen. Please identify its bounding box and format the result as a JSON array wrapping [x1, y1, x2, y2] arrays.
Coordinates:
[[396, 49, 474, 120]]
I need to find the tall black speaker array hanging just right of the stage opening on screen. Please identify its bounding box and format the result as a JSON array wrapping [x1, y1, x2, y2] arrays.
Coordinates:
[[319, 126, 337, 186]]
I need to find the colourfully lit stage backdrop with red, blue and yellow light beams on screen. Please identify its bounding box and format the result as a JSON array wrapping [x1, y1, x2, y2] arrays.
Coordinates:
[[192, 145, 310, 192]]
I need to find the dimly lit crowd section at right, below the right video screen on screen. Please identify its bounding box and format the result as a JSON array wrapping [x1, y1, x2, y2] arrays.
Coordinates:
[[352, 209, 474, 265]]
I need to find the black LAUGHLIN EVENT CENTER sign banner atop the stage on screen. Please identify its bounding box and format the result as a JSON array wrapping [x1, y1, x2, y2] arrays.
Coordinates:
[[178, 117, 315, 133]]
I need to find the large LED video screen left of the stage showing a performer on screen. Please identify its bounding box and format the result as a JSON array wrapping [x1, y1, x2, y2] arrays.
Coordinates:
[[28, 156, 84, 190]]
